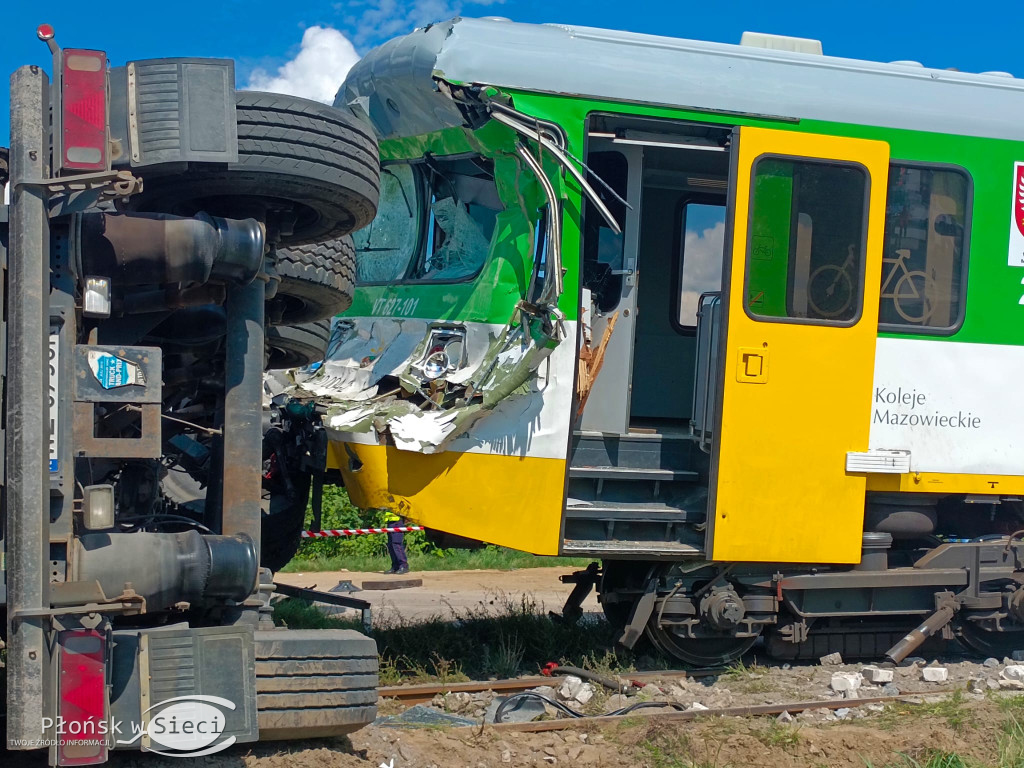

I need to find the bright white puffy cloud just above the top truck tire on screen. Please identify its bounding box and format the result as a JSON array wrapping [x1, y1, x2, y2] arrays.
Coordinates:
[[247, 27, 359, 103]]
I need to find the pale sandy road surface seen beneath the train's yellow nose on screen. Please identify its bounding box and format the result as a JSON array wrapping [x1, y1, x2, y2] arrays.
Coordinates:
[[274, 566, 601, 622]]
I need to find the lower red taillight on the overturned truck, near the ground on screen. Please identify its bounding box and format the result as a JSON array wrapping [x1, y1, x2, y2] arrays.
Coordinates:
[[55, 630, 109, 765]]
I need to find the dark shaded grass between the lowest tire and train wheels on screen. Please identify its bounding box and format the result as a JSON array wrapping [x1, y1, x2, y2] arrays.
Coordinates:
[[273, 595, 659, 685]]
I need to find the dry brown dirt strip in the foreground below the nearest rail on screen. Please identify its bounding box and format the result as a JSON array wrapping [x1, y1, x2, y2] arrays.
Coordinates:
[[4, 697, 1016, 768]]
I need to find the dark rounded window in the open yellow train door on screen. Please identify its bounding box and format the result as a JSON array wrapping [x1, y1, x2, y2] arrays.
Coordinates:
[[744, 157, 868, 326]]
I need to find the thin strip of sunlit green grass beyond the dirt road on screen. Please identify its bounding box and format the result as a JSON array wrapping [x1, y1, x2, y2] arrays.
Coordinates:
[[282, 548, 593, 573]]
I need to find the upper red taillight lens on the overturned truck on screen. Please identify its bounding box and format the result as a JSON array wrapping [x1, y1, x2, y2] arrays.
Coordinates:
[[60, 48, 108, 171]]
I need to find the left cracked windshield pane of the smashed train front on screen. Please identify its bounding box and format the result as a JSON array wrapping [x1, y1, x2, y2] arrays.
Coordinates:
[[352, 163, 422, 285]]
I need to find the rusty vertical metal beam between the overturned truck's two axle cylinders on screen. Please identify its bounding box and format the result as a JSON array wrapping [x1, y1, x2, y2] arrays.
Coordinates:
[[221, 280, 264, 553]]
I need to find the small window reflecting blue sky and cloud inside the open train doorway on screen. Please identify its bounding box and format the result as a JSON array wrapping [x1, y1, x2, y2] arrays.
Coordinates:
[[676, 202, 725, 329]]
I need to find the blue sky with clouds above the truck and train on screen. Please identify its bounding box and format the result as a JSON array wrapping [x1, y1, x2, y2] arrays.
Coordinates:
[[0, 0, 1024, 144]]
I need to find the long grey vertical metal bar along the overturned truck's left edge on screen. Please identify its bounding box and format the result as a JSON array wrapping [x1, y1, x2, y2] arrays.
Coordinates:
[[6, 67, 50, 749]]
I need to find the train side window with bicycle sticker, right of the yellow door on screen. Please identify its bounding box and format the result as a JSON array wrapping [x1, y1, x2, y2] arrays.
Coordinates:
[[879, 163, 972, 334]]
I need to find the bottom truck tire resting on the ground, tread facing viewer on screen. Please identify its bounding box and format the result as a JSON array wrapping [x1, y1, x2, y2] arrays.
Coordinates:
[[254, 630, 378, 740]]
